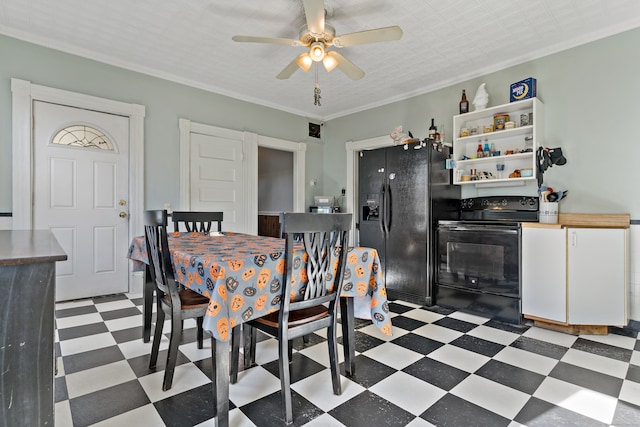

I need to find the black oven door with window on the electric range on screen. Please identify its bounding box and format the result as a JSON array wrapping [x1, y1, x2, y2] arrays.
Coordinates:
[[436, 221, 521, 298]]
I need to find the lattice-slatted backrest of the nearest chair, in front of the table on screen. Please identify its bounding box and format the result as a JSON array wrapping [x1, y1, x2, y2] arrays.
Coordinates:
[[280, 213, 352, 317]]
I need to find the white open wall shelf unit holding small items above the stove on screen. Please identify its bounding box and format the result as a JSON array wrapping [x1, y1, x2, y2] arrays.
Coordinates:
[[453, 98, 544, 186]]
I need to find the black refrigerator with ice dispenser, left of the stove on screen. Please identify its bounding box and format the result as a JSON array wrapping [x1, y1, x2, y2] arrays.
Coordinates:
[[358, 142, 460, 305]]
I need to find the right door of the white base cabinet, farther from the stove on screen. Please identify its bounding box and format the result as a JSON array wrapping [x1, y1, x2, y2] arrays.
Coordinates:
[[567, 228, 626, 325]]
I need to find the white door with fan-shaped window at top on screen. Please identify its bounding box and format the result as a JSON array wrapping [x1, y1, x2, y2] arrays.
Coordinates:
[[33, 101, 129, 301]]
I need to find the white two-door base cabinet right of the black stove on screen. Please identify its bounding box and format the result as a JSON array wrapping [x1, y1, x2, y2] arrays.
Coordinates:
[[522, 226, 629, 326]]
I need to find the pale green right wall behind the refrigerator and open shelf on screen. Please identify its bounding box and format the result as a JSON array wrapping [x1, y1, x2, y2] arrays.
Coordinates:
[[323, 25, 640, 220]]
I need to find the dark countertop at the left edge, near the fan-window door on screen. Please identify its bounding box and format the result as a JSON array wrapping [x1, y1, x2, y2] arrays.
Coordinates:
[[0, 230, 67, 266]]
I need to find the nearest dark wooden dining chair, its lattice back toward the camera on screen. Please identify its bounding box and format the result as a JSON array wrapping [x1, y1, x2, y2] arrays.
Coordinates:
[[231, 213, 352, 424]]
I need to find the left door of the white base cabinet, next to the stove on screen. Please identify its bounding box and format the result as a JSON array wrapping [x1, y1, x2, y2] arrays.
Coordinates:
[[522, 227, 567, 323]]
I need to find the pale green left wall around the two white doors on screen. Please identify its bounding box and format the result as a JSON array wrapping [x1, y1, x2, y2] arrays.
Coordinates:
[[0, 35, 323, 213]]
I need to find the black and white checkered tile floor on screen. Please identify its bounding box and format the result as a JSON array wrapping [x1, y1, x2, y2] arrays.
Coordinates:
[[55, 295, 640, 427]]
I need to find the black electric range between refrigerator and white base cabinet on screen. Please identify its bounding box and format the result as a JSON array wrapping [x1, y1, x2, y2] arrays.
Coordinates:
[[435, 196, 538, 324]]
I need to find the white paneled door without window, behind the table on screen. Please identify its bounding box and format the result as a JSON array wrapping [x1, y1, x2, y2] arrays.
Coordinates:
[[189, 131, 247, 232]]
